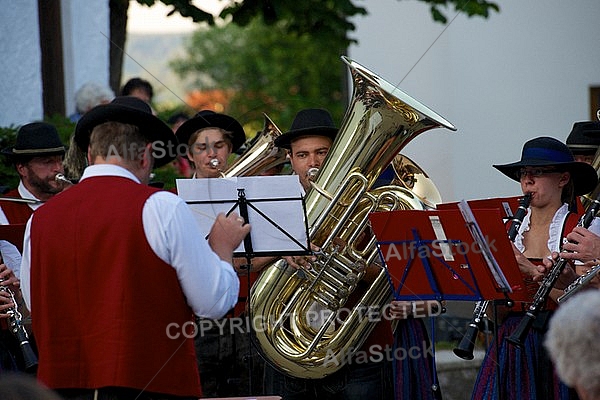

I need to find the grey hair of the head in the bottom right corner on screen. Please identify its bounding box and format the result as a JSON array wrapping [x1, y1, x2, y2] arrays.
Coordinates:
[[544, 289, 600, 399]]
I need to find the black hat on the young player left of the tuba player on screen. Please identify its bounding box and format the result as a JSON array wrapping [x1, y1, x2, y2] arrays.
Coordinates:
[[175, 110, 246, 152]]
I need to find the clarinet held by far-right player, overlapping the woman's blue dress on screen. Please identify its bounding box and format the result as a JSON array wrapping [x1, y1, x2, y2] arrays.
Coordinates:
[[506, 196, 600, 348]]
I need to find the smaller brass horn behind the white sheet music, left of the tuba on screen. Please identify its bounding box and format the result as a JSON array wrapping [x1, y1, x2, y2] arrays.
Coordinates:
[[222, 114, 287, 177]]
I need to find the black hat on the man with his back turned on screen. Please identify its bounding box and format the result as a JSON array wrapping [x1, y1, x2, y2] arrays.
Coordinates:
[[75, 96, 177, 167]]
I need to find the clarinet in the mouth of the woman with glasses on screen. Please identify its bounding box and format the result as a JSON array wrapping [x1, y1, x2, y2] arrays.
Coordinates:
[[453, 193, 531, 360]]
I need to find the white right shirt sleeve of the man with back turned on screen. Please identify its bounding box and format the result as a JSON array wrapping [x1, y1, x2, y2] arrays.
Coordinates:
[[142, 192, 240, 318]]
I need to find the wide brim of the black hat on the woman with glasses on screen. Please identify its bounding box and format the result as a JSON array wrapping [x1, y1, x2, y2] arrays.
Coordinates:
[[493, 160, 598, 196]]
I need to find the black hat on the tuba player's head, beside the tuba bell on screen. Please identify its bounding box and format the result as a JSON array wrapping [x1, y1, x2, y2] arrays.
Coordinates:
[[275, 108, 338, 149]]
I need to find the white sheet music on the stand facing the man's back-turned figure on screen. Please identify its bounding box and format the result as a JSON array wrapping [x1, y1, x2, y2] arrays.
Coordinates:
[[176, 175, 308, 254]]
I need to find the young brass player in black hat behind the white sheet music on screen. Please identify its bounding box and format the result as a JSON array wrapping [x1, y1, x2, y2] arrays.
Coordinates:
[[175, 110, 262, 397]]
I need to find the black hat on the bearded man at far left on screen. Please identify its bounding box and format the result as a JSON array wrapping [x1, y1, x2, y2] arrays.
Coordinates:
[[2, 122, 65, 158]]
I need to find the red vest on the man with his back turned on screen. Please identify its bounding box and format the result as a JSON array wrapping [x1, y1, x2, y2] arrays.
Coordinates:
[[31, 176, 201, 397]]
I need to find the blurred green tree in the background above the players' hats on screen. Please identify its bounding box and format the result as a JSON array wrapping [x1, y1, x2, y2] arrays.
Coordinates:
[[171, 19, 346, 130]]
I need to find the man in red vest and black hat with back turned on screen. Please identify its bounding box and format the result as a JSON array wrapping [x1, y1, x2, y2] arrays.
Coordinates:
[[21, 96, 250, 400]]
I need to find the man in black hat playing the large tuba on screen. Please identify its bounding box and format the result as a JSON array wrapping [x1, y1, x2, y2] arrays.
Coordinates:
[[265, 109, 393, 400]]
